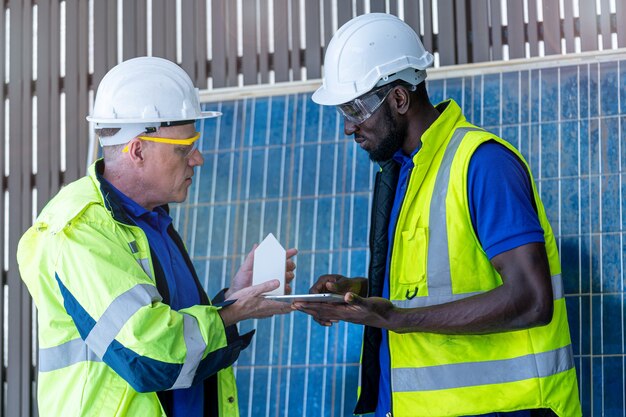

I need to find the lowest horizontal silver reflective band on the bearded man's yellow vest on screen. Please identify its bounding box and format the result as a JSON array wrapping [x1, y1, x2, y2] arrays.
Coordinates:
[[391, 345, 574, 392]]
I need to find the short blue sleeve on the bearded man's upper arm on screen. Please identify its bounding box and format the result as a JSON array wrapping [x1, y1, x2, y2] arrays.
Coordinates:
[[467, 141, 544, 259]]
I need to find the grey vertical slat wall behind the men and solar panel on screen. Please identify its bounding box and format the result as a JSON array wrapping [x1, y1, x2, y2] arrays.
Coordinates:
[[0, 0, 626, 416]]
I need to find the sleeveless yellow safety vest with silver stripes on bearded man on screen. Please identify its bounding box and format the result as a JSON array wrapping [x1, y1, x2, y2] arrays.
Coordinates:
[[355, 101, 581, 417]]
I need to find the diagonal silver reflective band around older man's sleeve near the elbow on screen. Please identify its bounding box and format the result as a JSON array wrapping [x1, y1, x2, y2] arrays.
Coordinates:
[[85, 284, 161, 358]]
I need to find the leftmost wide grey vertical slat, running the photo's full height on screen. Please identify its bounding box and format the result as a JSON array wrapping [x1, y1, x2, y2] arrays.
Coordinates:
[[6, 0, 33, 416]]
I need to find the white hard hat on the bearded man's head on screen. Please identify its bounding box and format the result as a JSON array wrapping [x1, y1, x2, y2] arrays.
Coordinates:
[[312, 13, 433, 106]]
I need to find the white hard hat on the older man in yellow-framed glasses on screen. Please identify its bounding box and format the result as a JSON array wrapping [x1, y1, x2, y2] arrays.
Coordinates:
[[87, 57, 221, 146]]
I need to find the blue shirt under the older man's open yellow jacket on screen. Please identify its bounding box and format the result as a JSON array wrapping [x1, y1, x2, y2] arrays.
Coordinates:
[[103, 179, 204, 417]]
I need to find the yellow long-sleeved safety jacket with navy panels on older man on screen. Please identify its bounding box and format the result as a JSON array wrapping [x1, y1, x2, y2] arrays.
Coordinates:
[[17, 160, 252, 417]]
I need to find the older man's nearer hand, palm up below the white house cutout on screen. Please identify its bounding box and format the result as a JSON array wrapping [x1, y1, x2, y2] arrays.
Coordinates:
[[219, 279, 295, 326]]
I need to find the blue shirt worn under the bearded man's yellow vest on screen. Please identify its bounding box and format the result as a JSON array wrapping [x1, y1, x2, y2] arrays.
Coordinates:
[[375, 142, 544, 417]]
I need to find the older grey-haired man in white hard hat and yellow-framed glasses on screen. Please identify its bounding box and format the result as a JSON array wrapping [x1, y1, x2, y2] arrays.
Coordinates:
[[18, 57, 297, 417]]
